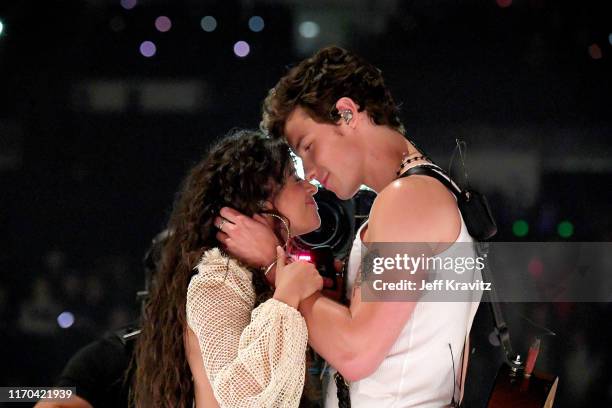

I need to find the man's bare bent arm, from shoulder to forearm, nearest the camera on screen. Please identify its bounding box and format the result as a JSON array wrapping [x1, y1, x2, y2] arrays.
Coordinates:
[[300, 177, 460, 381]]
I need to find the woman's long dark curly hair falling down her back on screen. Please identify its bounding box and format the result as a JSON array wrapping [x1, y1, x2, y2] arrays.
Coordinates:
[[132, 130, 293, 408]]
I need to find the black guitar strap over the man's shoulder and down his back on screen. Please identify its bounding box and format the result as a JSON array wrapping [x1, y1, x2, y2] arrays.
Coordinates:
[[398, 164, 515, 365]]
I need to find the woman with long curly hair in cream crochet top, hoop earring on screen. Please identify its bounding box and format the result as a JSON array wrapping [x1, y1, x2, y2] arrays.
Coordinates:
[[134, 131, 323, 407]]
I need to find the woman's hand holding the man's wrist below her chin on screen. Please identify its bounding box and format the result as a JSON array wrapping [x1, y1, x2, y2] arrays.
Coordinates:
[[273, 246, 323, 309]]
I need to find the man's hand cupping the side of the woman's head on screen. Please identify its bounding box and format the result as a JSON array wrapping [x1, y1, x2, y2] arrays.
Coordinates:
[[214, 207, 280, 267]]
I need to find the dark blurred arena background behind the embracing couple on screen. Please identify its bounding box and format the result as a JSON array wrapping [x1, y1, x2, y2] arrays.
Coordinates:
[[0, 0, 612, 407]]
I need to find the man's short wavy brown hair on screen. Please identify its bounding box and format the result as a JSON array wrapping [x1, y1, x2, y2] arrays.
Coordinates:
[[260, 46, 405, 137]]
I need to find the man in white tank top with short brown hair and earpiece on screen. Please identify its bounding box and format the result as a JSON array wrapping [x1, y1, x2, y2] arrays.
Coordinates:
[[215, 47, 480, 407]]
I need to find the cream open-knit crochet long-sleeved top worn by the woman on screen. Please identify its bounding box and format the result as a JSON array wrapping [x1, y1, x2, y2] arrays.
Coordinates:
[[187, 248, 308, 407]]
